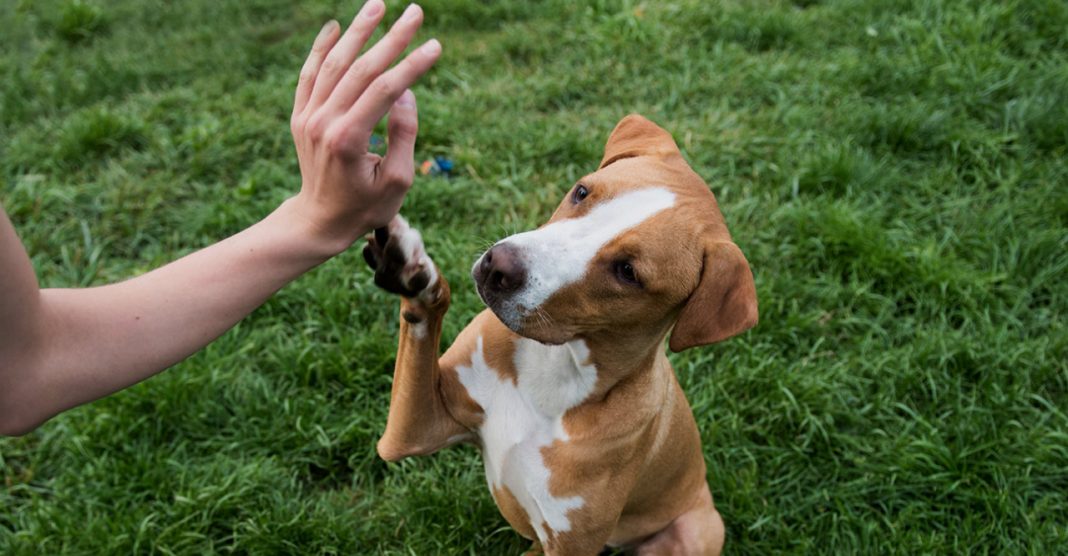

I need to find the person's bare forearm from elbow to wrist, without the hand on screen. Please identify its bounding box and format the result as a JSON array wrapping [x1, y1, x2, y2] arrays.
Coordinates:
[[6, 200, 344, 431]]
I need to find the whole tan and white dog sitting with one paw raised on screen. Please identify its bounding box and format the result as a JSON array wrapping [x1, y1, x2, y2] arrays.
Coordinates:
[[364, 115, 757, 555]]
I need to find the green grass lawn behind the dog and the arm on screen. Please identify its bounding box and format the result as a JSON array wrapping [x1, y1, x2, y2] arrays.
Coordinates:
[[0, 0, 1068, 555]]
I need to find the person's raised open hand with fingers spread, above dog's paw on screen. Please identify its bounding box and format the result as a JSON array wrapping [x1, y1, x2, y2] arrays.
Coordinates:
[[289, 0, 441, 253]]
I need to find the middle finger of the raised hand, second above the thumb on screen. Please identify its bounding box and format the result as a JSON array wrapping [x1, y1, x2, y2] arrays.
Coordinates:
[[326, 4, 423, 111]]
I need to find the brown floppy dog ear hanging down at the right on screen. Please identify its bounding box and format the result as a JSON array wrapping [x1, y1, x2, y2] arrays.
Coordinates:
[[669, 241, 757, 352]]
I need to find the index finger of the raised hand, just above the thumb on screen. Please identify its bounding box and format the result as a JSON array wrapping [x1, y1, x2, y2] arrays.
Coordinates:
[[344, 38, 441, 136]]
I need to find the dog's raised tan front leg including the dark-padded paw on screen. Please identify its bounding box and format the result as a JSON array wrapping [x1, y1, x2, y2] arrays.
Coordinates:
[[363, 216, 469, 461]]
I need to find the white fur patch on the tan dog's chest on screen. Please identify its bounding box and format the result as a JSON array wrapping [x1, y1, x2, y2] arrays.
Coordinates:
[[457, 337, 597, 541]]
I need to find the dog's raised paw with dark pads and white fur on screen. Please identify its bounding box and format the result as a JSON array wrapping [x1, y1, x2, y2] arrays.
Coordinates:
[[363, 215, 438, 301]]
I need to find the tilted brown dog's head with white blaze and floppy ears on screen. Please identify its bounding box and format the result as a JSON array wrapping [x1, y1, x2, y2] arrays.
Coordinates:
[[472, 116, 756, 350]]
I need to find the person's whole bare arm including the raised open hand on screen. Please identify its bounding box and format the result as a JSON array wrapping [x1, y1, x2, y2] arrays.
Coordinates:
[[0, 0, 440, 434]]
